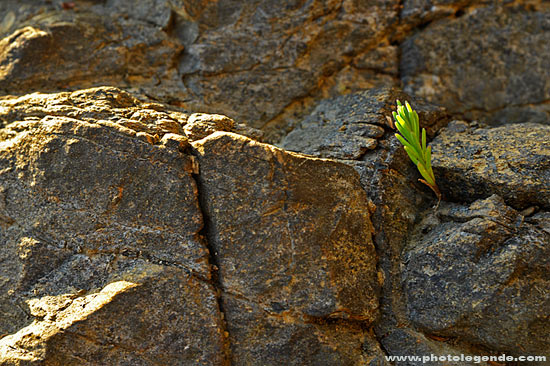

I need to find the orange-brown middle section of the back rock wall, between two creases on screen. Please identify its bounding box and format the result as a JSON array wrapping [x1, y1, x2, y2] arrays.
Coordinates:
[[180, 0, 398, 135]]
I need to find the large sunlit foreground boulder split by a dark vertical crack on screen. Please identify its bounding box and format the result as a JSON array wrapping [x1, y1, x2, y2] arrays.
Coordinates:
[[0, 88, 390, 365]]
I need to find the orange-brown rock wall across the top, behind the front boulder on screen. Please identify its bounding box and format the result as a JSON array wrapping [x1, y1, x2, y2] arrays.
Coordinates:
[[4, 0, 550, 139]]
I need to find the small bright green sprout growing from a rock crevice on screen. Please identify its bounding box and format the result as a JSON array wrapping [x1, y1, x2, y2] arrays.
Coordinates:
[[393, 100, 441, 201]]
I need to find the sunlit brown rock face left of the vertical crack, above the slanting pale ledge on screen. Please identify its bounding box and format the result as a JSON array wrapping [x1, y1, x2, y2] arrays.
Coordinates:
[[0, 108, 215, 344]]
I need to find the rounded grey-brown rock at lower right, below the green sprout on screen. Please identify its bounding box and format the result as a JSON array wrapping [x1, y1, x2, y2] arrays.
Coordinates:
[[403, 195, 550, 355]]
